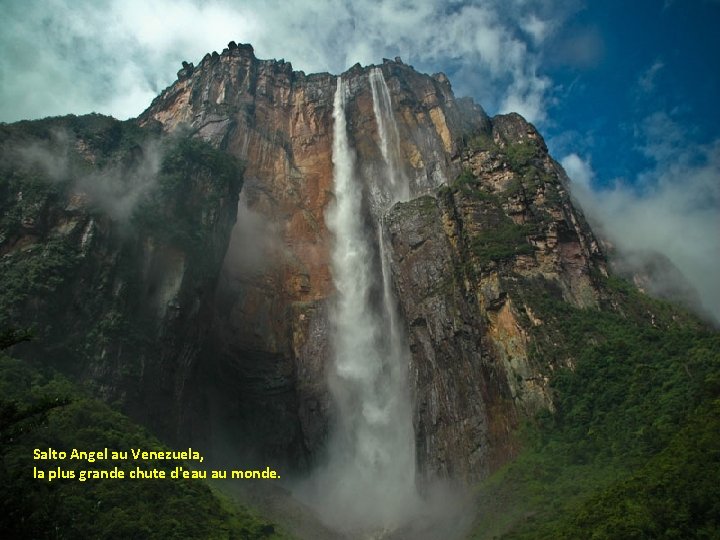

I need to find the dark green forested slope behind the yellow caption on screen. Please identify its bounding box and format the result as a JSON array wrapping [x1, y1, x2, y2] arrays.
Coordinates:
[[0, 353, 281, 539]]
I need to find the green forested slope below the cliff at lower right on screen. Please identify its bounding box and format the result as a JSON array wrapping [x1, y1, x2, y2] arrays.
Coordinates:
[[473, 278, 720, 540]]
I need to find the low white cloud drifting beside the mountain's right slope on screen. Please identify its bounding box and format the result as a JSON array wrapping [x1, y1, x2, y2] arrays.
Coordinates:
[[562, 112, 720, 320]]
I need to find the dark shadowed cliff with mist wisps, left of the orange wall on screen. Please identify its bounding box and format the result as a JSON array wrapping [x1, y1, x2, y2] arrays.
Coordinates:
[[0, 115, 242, 448]]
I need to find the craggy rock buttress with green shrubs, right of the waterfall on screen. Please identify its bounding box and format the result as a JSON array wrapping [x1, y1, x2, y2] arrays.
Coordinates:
[[386, 115, 605, 479]]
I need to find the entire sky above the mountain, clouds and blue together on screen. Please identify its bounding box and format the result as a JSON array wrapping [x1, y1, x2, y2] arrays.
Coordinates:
[[0, 0, 720, 317]]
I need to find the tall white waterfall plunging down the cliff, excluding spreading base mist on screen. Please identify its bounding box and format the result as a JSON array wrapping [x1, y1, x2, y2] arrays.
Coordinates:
[[308, 74, 419, 534]]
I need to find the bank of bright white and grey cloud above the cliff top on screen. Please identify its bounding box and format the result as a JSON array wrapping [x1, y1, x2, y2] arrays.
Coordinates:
[[0, 0, 562, 122]]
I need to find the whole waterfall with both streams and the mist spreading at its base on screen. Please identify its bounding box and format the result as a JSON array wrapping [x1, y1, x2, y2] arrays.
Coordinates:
[[294, 73, 470, 539]]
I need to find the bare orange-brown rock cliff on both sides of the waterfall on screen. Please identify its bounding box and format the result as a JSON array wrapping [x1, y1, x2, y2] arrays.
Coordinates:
[[140, 43, 604, 479]]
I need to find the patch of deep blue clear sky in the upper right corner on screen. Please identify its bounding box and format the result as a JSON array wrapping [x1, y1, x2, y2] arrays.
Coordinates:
[[544, 0, 720, 184]]
